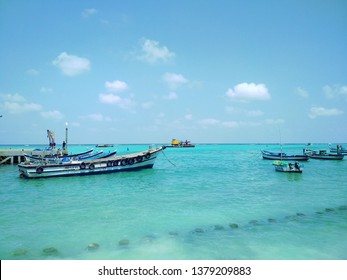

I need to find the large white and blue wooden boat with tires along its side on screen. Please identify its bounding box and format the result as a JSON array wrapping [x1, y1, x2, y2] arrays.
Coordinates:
[[18, 146, 165, 178]]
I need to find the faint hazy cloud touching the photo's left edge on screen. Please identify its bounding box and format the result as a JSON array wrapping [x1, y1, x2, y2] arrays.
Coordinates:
[[0, 93, 42, 114]]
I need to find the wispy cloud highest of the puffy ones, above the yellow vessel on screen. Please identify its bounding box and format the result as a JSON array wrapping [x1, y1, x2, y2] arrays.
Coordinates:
[[138, 39, 175, 64]]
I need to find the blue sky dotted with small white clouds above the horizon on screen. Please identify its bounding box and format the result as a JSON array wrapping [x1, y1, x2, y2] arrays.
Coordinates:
[[0, 0, 347, 144]]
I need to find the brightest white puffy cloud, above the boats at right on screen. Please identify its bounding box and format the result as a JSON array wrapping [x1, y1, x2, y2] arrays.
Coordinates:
[[226, 83, 271, 102]]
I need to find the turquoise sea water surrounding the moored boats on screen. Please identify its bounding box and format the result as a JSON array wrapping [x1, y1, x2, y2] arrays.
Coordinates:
[[0, 144, 347, 260]]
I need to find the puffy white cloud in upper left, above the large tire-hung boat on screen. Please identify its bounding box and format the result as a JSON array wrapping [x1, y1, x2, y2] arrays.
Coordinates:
[[52, 52, 90, 76]]
